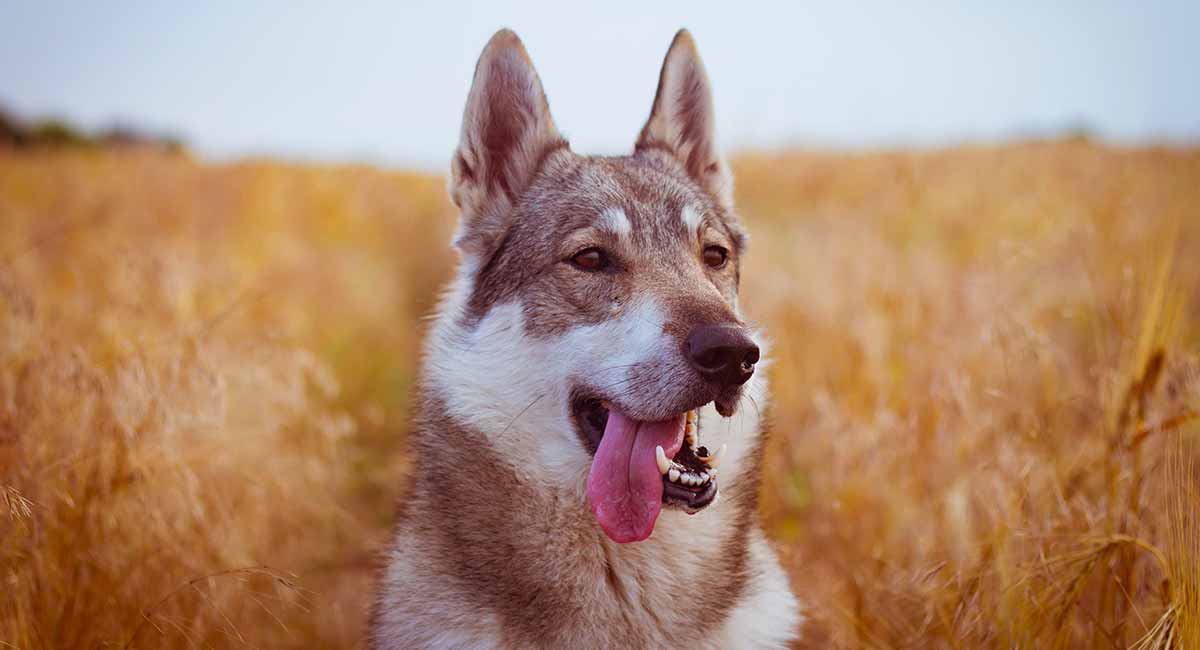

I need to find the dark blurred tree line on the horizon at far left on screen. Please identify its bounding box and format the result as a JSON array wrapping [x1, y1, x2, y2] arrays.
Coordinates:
[[0, 109, 185, 154]]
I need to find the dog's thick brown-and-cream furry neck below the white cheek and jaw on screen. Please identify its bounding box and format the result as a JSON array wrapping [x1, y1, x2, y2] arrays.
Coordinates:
[[400, 397, 758, 645]]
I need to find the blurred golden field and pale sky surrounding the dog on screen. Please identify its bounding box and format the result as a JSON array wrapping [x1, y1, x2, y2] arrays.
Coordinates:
[[0, 2, 1200, 649]]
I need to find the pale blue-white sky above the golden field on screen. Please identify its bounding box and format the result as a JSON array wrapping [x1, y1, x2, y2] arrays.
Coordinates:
[[0, 0, 1200, 170]]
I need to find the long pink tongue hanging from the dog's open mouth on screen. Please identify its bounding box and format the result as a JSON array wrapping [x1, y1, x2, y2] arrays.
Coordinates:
[[588, 409, 683, 543]]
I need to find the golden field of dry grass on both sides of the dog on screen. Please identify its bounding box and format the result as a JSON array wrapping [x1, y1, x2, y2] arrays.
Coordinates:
[[0, 142, 1200, 650]]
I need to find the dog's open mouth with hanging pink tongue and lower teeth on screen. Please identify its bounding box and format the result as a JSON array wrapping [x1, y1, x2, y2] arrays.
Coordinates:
[[571, 398, 725, 542]]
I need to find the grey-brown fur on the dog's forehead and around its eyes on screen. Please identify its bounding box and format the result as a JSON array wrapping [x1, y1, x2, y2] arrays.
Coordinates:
[[468, 150, 743, 336]]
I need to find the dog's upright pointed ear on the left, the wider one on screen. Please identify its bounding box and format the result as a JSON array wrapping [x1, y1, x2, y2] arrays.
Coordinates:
[[450, 29, 566, 257]]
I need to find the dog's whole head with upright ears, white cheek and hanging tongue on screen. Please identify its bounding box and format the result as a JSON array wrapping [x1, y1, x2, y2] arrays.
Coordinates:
[[427, 30, 760, 542]]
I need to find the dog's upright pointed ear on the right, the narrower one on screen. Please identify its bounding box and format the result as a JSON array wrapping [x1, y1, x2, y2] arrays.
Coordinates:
[[634, 29, 733, 207]]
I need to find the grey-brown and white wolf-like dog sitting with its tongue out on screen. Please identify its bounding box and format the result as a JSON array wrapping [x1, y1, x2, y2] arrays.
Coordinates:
[[368, 30, 802, 650]]
